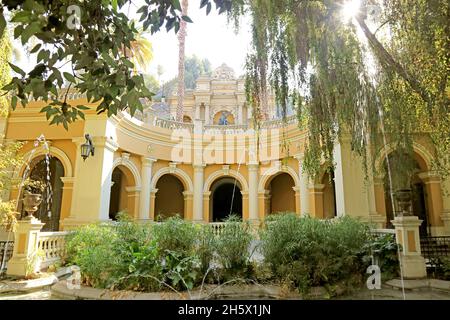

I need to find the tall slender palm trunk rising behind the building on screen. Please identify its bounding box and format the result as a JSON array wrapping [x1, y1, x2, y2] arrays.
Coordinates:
[[176, 0, 188, 122]]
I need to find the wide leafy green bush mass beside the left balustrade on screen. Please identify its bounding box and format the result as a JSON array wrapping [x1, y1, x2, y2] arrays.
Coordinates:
[[67, 215, 200, 291]]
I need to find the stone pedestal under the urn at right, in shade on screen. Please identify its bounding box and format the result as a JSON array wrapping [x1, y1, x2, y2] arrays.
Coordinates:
[[392, 216, 427, 279]]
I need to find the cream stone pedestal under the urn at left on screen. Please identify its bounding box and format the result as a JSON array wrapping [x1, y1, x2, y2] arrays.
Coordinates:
[[6, 217, 44, 277]]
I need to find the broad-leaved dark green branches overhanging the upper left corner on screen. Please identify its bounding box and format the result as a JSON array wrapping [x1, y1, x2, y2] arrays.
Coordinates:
[[0, 0, 231, 129]]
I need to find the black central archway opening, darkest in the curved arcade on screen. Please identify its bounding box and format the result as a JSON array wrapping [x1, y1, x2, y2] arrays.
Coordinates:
[[212, 182, 242, 222]]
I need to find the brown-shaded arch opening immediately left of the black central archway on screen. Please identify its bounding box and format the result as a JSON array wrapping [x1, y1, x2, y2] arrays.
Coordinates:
[[155, 174, 185, 220]]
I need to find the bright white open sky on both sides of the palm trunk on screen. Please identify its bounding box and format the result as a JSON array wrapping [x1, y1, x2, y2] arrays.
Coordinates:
[[142, 4, 251, 81]]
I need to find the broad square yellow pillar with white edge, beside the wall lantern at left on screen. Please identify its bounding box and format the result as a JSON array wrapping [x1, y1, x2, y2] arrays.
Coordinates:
[[64, 136, 118, 226]]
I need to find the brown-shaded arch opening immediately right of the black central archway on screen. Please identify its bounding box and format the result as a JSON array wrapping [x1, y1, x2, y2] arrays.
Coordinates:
[[266, 172, 296, 213]]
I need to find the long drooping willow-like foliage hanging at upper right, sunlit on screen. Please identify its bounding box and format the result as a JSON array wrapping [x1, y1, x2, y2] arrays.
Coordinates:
[[228, 0, 450, 181]]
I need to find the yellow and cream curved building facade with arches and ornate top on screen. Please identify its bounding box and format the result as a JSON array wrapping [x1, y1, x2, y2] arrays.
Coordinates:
[[0, 66, 450, 236]]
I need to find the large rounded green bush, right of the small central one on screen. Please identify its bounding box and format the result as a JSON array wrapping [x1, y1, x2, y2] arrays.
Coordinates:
[[260, 214, 369, 292]]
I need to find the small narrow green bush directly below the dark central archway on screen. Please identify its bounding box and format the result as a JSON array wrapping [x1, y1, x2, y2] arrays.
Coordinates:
[[215, 216, 253, 280]]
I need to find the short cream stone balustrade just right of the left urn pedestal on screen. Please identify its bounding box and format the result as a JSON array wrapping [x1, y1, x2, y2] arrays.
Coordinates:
[[38, 231, 70, 269]]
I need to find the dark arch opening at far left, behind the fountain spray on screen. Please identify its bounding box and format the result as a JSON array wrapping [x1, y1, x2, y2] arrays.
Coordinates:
[[19, 156, 65, 231]]
